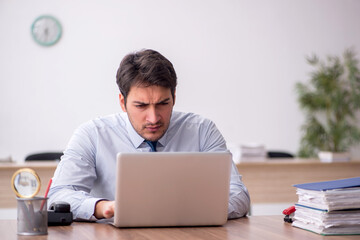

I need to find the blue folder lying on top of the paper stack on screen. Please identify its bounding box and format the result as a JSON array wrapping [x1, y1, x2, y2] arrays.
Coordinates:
[[294, 177, 360, 191]]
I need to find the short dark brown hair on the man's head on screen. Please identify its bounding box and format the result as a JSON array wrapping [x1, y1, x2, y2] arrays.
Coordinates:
[[116, 49, 177, 101]]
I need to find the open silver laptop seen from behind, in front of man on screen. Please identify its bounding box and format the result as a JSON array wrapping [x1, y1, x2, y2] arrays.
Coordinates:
[[113, 152, 232, 227]]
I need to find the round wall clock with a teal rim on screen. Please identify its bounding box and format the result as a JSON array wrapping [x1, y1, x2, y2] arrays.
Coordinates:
[[31, 15, 62, 46]]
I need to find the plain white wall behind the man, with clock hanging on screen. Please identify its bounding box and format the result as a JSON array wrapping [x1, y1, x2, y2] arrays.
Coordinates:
[[0, 0, 360, 161]]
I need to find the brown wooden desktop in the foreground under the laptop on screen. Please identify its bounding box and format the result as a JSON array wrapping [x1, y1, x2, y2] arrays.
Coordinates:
[[0, 216, 360, 240]]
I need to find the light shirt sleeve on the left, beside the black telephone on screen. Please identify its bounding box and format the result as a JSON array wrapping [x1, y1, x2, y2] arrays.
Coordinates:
[[48, 125, 102, 220]]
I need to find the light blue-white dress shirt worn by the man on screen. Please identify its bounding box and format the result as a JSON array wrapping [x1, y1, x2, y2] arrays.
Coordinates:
[[48, 111, 250, 220]]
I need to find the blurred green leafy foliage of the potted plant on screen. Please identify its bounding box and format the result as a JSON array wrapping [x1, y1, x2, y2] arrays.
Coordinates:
[[296, 49, 360, 157]]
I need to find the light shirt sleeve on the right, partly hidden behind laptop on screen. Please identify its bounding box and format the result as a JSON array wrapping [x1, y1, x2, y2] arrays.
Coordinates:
[[200, 121, 250, 219]]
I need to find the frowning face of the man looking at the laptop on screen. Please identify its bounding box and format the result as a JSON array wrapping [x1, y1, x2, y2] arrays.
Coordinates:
[[119, 86, 175, 141]]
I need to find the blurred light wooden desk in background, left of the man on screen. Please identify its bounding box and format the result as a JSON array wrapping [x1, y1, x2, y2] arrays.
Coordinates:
[[0, 161, 58, 208]]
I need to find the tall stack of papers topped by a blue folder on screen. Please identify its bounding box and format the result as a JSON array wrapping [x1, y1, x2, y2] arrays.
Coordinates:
[[292, 177, 360, 235]]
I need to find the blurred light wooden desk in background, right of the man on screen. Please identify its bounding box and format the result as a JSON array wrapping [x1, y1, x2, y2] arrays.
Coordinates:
[[237, 159, 360, 203]]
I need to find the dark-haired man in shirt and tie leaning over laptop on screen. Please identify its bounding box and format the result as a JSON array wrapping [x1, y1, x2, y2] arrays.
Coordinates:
[[49, 50, 250, 220]]
